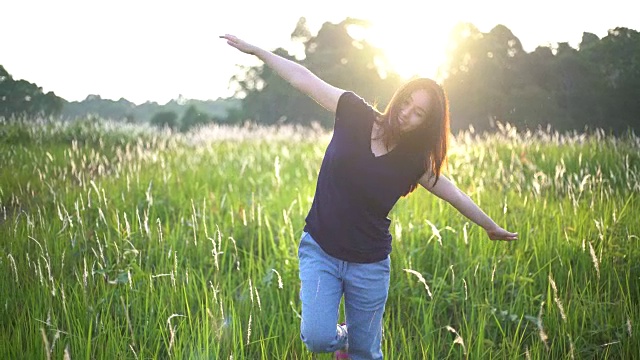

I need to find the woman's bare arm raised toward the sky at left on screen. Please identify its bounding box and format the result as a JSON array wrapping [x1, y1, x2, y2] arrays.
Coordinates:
[[220, 34, 344, 113]]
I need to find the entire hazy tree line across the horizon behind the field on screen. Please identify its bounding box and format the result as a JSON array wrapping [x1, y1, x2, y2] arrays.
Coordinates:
[[0, 18, 640, 134]]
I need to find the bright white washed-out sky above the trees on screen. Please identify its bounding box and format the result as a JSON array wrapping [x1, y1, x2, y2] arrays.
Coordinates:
[[0, 0, 640, 104]]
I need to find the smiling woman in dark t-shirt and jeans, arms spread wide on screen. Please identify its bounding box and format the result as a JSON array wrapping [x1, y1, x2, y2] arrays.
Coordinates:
[[221, 35, 517, 359]]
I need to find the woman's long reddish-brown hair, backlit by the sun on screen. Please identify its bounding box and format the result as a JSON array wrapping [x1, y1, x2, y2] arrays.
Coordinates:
[[377, 78, 449, 195]]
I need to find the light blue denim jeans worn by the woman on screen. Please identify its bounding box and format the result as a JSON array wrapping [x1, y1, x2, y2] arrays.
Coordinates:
[[298, 232, 391, 360]]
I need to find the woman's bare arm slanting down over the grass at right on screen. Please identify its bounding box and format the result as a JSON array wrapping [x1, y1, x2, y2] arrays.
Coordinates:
[[419, 173, 518, 241]]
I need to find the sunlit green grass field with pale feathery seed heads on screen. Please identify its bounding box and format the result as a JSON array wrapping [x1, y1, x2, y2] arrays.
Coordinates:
[[0, 121, 640, 359]]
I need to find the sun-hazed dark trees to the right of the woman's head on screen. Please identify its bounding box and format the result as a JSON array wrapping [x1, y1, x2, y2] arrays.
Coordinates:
[[444, 24, 640, 134]]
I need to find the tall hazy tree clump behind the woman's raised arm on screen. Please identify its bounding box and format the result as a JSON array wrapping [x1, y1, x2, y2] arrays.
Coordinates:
[[232, 18, 400, 127]]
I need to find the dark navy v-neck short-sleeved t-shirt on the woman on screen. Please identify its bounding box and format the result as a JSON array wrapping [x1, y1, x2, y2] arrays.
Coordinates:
[[304, 91, 425, 263]]
